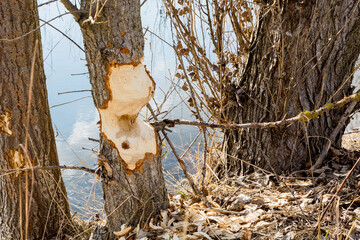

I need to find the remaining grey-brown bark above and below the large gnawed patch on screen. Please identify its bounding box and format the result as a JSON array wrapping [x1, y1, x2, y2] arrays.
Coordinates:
[[63, 0, 169, 232]]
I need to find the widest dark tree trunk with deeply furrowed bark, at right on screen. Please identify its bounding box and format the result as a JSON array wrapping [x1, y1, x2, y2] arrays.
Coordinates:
[[225, 0, 360, 174]]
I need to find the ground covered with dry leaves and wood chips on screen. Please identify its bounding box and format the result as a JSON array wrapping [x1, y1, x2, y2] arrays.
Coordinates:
[[72, 133, 360, 240]]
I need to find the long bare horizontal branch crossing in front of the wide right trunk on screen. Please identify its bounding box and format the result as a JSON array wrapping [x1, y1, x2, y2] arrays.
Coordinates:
[[151, 92, 360, 129]]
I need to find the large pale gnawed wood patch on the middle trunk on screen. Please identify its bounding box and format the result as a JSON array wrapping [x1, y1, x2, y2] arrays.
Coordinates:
[[99, 63, 157, 170]]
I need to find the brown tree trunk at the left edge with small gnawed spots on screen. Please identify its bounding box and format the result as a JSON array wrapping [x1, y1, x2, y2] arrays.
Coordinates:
[[0, 0, 70, 239]]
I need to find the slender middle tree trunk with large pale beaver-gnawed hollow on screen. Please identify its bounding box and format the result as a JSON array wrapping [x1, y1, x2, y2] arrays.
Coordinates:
[[63, 0, 169, 232]]
